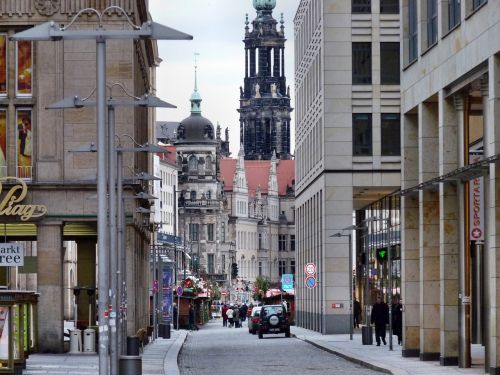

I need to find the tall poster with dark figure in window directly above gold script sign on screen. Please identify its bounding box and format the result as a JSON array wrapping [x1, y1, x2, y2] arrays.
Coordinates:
[[17, 109, 33, 178]]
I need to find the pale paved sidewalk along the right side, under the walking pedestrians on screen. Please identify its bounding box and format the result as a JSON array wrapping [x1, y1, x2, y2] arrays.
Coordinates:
[[291, 326, 484, 375]]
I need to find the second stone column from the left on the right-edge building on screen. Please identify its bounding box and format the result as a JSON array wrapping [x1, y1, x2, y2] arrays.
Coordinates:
[[418, 102, 439, 361]]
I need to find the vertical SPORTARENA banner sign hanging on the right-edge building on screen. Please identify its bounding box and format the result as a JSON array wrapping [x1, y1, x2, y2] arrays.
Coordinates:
[[469, 155, 484, 241]]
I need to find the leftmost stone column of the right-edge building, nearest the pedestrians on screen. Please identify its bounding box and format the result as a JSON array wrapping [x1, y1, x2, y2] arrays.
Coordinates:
[[401, 114, 420, 357]]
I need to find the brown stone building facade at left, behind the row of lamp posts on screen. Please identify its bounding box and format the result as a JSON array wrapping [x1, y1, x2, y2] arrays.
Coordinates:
[[0, 0, 167, 352]]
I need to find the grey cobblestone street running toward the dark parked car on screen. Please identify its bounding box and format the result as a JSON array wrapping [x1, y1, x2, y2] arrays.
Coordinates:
[[179, 321, 380, 375]]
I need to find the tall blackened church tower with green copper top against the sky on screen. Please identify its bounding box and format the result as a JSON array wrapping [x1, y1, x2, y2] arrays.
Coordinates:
[[238, 0, 292, 160]]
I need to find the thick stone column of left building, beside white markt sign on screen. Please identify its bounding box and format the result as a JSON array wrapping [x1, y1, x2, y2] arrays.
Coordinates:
[[37, 221, 64, 353]]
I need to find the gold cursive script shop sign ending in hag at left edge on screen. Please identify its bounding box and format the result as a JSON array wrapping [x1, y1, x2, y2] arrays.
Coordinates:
[[0, 177, 47, 221]]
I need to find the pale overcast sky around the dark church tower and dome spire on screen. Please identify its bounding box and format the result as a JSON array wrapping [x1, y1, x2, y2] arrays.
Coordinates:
[[149, 0, 300, 157]]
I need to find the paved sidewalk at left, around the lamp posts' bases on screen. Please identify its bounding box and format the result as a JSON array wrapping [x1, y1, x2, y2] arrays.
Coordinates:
[[23, 330, 188, 375]]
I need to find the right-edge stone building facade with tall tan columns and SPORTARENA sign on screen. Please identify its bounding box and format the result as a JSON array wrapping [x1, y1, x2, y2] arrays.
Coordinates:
[[401, 0, 500, 374]]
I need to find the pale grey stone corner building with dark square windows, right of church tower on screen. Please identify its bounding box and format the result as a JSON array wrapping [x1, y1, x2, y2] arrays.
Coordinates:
[[294, 0, 400, 333]]
